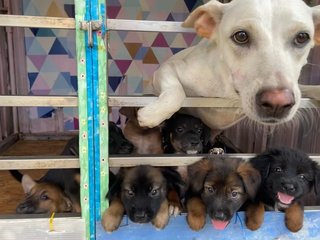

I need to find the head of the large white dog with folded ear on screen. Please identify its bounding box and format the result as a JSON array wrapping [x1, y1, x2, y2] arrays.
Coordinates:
[[183, 0, 320, 124]]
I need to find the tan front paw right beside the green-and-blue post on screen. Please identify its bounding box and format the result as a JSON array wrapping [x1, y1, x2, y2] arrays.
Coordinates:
[[101, 198, 125, 232]]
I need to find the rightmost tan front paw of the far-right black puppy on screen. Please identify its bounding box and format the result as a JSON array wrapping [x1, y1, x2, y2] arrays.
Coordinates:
[[285, 203, 303, 232]]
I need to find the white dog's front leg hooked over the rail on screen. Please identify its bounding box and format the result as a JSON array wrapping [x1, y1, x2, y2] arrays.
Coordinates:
[[138, 65, 186, 128]]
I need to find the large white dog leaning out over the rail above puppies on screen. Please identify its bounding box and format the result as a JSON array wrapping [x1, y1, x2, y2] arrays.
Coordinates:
[[138, 0, 320, 129]]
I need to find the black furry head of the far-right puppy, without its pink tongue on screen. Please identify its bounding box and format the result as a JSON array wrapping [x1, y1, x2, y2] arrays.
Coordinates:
[[250, 148, 320, 209]]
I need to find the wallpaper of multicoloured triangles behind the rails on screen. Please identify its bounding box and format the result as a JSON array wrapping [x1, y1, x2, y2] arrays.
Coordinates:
[[23, 0, 206, 130]]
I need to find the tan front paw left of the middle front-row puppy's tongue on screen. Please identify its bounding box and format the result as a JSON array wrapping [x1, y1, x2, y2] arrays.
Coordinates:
[[187, 197, 206, 231]]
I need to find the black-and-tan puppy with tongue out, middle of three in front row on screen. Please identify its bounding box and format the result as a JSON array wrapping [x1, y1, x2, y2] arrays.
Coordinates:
[[186, 156, 261, 231]]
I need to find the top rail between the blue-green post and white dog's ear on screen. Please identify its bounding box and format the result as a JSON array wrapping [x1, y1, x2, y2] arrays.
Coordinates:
[[107, 19, 194, 32]]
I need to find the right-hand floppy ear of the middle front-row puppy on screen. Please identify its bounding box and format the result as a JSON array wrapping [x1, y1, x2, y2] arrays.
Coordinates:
[[237, 163, 261, 199]]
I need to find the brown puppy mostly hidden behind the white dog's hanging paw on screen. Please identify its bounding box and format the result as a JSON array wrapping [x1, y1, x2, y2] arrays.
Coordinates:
[[119, 107, 163, 154]]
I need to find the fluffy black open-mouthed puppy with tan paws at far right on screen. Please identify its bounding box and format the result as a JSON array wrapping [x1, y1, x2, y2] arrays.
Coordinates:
[[246, 148, 319, 232]]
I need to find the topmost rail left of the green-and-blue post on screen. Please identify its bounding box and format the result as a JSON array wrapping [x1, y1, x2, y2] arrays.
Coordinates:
[[0, 14, 76, 29]]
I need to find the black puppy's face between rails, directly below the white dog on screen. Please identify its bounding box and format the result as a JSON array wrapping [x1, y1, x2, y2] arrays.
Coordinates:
[[162, 113, 210, 154]]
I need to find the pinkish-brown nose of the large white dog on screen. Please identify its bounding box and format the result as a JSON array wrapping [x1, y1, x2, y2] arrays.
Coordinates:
[[256, 88, 295, 118]]
